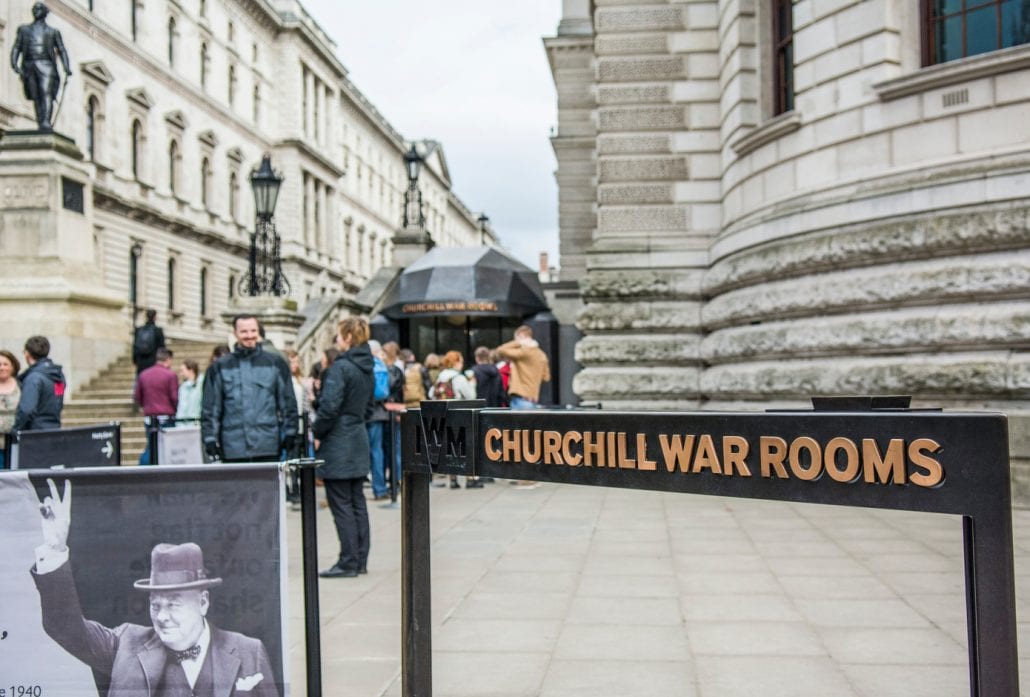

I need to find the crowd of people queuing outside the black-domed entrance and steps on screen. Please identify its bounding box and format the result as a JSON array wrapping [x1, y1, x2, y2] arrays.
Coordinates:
[[0, 311, 550, 579]]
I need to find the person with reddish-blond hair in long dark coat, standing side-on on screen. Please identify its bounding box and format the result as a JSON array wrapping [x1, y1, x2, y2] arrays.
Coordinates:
[[311, 317, 373, 579]]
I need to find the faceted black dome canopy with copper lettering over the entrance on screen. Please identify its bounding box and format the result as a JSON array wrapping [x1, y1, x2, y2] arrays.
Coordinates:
[[380, 247, 547, 319]]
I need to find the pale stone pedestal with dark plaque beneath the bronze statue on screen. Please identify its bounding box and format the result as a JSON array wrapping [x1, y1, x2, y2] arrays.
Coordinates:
[[0, 131, 126, 391]]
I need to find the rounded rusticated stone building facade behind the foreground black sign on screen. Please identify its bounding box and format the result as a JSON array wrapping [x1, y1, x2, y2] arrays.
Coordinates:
[[545, 0, 1030, 473]]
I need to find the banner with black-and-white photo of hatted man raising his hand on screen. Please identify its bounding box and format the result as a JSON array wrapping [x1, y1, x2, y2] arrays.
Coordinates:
[[0, 466, 288, 697]]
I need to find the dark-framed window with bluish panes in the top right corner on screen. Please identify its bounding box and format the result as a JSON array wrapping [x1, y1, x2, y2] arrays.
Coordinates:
[[923, 0, 1030, 65]]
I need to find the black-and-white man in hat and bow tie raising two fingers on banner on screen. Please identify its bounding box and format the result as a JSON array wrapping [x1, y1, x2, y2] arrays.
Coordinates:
[[32, 480, 279, 697]]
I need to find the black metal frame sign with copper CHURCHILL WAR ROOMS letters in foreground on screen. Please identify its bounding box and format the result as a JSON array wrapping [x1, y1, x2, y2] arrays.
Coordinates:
[[402, 402, 1019, 697]]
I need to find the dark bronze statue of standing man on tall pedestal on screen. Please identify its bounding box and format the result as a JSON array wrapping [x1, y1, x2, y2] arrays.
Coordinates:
[[10, 2, 71, 131]]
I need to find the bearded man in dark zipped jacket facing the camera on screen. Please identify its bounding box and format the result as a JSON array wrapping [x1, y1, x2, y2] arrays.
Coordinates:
[[201, 315, 297, 462]]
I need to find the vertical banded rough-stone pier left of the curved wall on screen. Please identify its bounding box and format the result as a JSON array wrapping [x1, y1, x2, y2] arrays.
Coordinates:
[[575, 0, 719, 409]]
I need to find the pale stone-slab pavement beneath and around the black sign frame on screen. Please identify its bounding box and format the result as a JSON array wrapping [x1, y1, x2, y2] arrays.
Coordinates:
[[287, 481, 1030, 697]]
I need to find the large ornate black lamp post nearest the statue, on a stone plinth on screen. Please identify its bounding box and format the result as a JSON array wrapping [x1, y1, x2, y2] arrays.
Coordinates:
[[240, 154, 289, 298]]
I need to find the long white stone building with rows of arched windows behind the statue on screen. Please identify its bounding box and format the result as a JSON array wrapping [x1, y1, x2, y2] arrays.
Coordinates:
[[0, 0, 493, 388]]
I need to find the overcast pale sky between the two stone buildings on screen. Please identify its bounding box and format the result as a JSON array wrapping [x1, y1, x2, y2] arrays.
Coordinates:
[[301, 0, 561, 269]]
